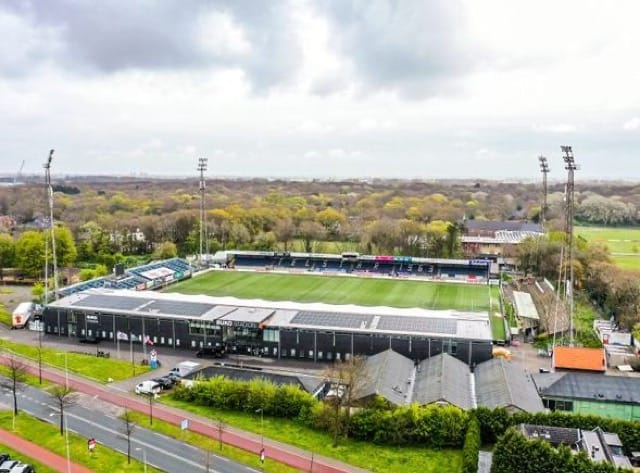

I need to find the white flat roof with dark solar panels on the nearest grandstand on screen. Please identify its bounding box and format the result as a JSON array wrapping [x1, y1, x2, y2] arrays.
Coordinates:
[[47, 289, 492, 340]]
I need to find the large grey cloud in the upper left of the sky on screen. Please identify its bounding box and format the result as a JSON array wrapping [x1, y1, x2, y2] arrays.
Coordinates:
[[0, 0, 302, 90]]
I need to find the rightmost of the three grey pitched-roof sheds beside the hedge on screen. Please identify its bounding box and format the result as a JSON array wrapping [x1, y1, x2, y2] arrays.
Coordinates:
[[474, 358, 545, 413]]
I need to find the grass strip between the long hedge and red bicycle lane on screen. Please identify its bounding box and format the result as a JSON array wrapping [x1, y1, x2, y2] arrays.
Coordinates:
[[159, 397, 462, 473]]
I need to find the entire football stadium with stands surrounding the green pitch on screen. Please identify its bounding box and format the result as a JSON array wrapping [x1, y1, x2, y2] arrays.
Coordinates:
[[44, 251, 499, 365]]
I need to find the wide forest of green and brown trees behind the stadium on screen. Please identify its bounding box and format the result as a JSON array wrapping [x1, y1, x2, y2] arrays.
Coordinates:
[[0, 178, 640, 334]]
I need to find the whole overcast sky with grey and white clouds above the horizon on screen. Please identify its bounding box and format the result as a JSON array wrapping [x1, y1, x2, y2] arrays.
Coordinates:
[[0, 0, 640, 179]]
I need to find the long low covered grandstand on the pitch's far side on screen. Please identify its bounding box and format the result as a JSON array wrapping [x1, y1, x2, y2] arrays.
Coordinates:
[[213, 250, 490, 283]]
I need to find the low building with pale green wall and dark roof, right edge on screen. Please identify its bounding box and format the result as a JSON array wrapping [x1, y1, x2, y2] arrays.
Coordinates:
[[533, 372, 640, 421]]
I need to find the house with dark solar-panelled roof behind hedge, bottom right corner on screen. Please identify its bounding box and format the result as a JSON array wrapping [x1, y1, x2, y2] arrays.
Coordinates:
[[517, 424, 631, 468]]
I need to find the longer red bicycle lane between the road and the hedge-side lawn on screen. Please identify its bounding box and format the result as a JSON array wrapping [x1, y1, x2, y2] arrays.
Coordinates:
[[2, 356, 367, 473]]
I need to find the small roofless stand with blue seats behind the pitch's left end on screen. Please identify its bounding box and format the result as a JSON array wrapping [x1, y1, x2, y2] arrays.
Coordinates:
[[58, 258, 193, 296]]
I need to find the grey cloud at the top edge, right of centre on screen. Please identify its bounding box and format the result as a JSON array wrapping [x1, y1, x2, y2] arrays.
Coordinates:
[[322, 0, 473, 97]]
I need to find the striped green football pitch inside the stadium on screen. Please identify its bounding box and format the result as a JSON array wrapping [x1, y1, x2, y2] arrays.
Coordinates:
[[165, 271, 499, 311]]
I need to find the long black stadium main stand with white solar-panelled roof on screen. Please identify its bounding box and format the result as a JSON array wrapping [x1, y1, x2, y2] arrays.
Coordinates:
[[43, 289, 492, 365]]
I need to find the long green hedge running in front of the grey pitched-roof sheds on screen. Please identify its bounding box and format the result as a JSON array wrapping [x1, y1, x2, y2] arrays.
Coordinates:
[[174, 376, 640, 454]]
